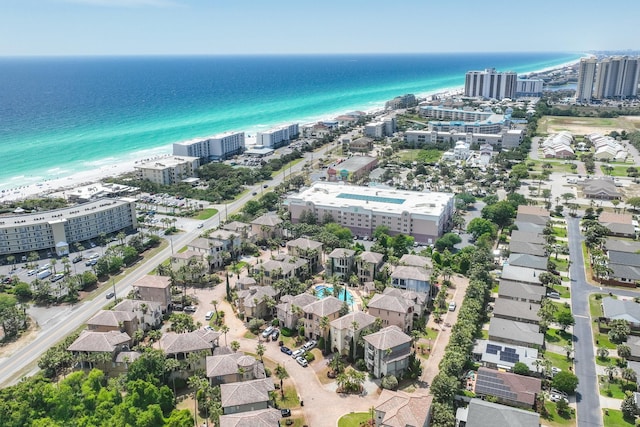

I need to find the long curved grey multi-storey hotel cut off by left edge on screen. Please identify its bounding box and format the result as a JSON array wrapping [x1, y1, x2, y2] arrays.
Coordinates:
[[0, 198, 137, 256]]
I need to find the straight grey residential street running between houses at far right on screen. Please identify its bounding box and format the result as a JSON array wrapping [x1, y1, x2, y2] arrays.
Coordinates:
[[567, 218, 602, 427]]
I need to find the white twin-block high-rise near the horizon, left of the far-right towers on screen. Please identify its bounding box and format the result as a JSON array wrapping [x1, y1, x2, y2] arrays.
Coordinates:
[[464, 68, 518, 99]]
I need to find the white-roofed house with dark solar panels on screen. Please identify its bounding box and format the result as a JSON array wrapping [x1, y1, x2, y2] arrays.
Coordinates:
[[471, 340, 538, 372]]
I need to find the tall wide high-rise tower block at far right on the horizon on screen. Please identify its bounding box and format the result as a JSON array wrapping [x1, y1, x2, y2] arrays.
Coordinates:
[[594, 56, 640, 99]]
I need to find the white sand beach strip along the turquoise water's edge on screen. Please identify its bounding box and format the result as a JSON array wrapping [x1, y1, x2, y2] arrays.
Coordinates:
[[0, 59, 579, 202]]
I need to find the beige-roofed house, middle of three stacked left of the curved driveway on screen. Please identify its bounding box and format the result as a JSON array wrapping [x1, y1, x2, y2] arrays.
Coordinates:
[[220, 378, 275, 415]]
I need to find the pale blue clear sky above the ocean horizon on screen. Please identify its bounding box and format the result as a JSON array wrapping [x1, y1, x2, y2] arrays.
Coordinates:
[[0, 0, 640, 56]]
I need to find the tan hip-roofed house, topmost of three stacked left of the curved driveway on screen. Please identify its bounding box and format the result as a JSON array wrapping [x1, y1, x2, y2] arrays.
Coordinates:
[[206, 352, 266, 385]]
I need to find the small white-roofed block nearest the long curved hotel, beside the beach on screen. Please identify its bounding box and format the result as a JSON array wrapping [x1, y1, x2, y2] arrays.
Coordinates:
[[135, 156, 200, 185]]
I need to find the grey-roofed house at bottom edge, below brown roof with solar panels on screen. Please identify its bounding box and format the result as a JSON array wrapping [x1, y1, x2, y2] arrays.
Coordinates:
[[456, 399, 540, 427]]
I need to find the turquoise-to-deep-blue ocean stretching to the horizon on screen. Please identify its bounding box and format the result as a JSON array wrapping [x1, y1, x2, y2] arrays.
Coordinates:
[[0, 53, 581, 189]]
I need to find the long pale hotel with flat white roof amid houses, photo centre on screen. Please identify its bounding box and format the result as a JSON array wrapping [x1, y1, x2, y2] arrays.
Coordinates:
[[285, 182, 454, 244]]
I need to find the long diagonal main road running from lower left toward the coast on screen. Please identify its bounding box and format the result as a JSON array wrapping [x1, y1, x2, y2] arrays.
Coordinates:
[[0, 144, 335, 386]]
